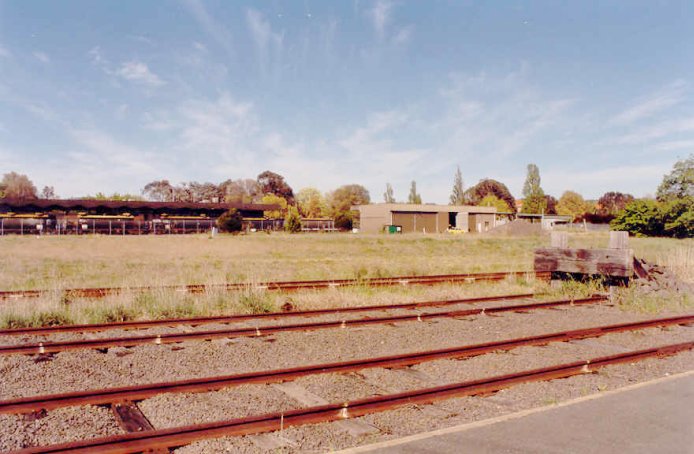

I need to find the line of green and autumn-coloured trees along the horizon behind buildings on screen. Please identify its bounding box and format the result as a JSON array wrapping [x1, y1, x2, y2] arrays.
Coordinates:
[[0, 156, 694, 237]]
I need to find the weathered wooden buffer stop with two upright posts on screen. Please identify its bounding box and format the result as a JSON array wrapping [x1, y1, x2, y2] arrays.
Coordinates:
[[534, 232, 634, 285]]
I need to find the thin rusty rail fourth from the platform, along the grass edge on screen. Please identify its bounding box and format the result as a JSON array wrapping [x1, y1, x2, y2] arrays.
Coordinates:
[[0, 293, 535, 336]]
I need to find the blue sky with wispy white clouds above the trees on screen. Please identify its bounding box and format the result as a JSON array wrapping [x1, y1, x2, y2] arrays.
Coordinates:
[[0, 0, 694, 203]]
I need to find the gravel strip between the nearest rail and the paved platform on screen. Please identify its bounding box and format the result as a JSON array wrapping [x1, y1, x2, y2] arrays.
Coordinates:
[[181, 351, 694, 454]]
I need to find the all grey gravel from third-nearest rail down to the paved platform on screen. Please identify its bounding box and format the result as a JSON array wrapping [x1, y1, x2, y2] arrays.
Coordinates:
[[0, 304, 694, 452]]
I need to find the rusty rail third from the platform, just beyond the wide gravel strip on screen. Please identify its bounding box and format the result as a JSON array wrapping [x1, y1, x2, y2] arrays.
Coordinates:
[[0, 296, 607, 355]]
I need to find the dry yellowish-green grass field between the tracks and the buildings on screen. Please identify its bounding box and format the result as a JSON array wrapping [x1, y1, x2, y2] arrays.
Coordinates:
[[0, 233, 694, 326]]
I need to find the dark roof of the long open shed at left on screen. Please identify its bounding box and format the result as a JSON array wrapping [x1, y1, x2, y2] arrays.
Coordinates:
[[0, 198, 280, 211]]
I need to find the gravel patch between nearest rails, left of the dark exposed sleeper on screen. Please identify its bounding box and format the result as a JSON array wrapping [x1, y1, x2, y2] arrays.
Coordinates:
[[0, 406, 122, 452]]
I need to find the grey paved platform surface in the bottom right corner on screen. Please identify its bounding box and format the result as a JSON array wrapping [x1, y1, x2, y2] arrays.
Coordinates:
[[354, 373, 694, 454]]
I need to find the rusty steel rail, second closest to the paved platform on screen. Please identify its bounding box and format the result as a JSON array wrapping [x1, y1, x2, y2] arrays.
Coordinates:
[[0, 314, 694, 414]]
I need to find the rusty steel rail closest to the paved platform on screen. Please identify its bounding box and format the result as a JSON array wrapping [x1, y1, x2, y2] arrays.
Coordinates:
[[17, 341, 694, 454]]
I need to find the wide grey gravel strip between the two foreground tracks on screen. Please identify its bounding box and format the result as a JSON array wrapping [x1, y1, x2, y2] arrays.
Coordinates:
[[0, 305, 688, 399]]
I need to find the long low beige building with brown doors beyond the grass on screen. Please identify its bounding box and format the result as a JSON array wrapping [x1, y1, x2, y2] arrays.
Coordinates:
[[352, 203, 496, 233]]
